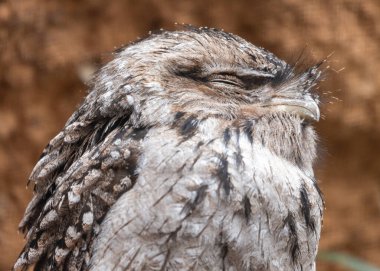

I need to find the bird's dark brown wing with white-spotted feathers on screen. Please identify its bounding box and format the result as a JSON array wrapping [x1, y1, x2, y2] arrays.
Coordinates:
[[14, 78, 142, 270]]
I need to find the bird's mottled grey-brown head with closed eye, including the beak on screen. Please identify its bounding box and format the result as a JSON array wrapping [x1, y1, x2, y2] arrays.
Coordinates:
[[87, 28, 321, 128]]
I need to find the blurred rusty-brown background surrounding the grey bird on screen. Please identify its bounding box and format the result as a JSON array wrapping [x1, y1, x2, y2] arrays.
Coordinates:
[[0, 0, 380, 270]]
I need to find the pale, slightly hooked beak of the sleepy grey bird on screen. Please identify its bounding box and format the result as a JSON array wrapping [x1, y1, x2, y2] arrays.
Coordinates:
[[264, 96, 320, 121]]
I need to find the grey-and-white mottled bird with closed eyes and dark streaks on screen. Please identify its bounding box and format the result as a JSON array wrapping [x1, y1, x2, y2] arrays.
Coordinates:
[[13, 27, 324, 271]]
